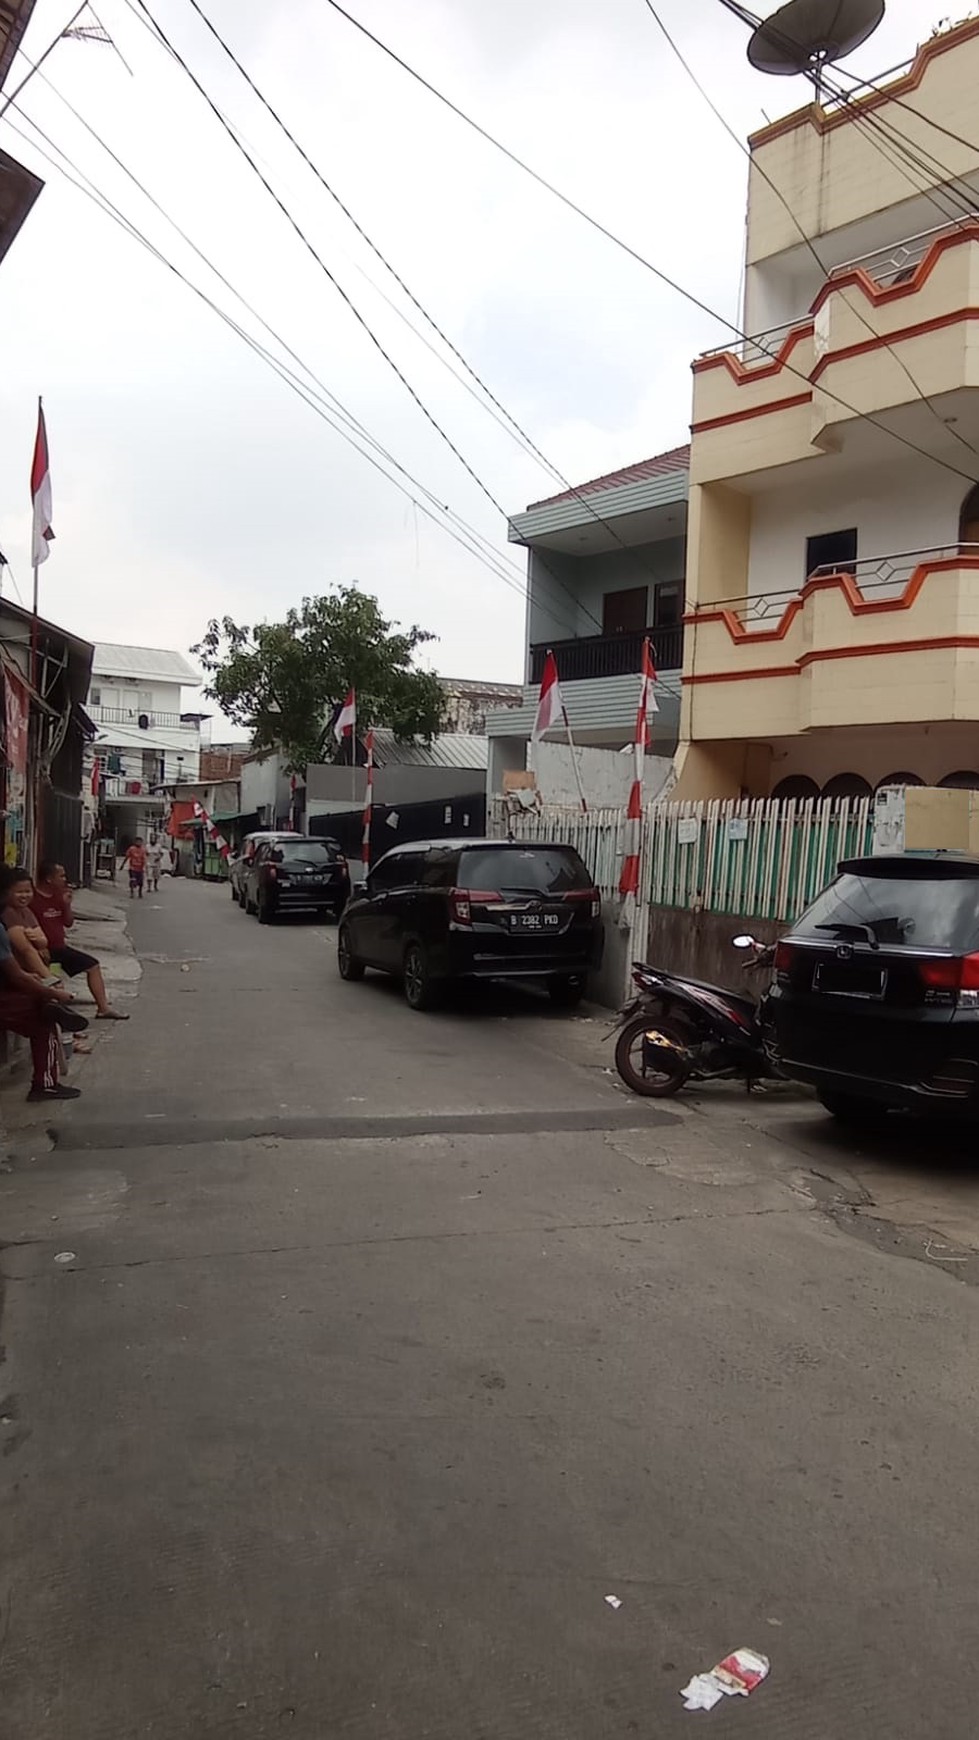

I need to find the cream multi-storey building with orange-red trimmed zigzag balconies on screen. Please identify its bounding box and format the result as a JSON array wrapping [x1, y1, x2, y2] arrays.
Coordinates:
[[676, 19, 979, 797]]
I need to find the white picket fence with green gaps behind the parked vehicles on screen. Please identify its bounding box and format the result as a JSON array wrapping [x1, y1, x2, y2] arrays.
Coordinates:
[[494, 797, 873, 920]]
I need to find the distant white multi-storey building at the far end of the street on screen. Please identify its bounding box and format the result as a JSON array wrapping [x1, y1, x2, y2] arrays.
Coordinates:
[[87, 642, 207, 839]]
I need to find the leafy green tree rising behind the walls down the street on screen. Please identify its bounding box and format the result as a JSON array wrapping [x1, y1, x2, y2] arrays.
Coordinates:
[[191, 586, 445, 769]]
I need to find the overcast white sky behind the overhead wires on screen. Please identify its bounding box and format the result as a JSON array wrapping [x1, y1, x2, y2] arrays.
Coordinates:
[[0, 0, 942, 720]]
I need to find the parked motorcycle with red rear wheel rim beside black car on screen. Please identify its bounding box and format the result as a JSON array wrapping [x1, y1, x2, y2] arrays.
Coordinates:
[[616, 936, 779, 1100]]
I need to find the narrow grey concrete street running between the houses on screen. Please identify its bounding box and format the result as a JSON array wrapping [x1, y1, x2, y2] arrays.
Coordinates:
[[0, 880, 979, 1740]]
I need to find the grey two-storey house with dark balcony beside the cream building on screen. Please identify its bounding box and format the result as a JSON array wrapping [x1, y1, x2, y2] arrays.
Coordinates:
[[487, 447, 689, 800]]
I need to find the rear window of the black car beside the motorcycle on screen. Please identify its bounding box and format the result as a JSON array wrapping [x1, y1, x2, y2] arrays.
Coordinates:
[[793, 873, 979, 954]]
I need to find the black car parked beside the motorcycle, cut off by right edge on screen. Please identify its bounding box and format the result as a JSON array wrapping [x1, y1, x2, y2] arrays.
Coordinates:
[[769, 853, 979, 1119]]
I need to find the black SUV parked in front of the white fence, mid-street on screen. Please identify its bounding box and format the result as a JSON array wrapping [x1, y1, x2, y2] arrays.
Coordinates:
[[337, 840, 602, 1009]]
